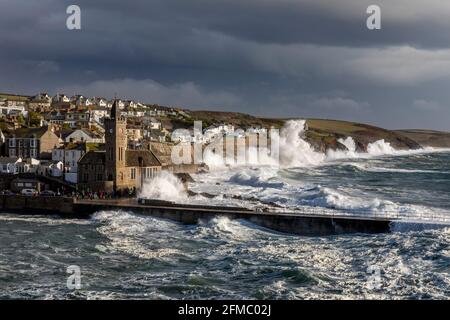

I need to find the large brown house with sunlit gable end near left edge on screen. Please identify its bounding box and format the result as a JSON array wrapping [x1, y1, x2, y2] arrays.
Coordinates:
[[6, 127, 60, 159]]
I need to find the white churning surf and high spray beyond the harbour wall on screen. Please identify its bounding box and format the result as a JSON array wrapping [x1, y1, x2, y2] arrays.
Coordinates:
[[188, 120, 449, 222]]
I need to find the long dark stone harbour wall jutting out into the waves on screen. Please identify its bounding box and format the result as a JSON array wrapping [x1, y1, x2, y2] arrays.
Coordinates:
[[0, 195, 390, 236]]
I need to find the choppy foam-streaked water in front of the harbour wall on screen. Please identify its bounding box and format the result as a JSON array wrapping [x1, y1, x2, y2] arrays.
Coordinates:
[[0, 211, 450, 299]]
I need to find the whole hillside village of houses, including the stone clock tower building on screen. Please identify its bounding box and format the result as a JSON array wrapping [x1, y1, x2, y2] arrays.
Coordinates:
[[0, 93, 265, 197]]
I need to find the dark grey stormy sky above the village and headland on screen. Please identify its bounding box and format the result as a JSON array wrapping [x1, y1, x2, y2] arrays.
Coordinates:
[[0, 0, 450, 131]]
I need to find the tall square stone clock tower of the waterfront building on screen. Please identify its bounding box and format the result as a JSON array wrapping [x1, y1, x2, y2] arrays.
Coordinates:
[[105, 100, 128, 191]]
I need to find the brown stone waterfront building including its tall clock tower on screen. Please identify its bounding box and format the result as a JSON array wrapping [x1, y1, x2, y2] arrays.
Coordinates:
[[78, 101, 161, 193]]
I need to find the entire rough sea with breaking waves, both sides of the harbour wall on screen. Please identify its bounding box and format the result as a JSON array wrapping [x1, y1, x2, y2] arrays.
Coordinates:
[[0, 121, 450, 299]]
